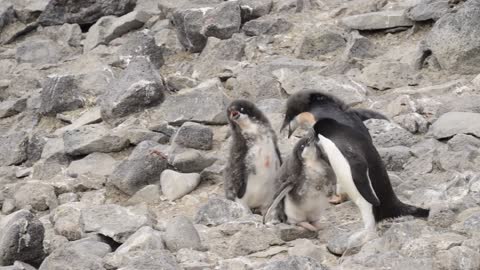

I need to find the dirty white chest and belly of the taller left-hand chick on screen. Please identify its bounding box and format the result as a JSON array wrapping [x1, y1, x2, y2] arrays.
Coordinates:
[[241, 138, 280, 208]]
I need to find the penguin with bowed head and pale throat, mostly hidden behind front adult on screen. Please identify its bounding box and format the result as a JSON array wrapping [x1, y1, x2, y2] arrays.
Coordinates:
[[280, 90, 387, 204]]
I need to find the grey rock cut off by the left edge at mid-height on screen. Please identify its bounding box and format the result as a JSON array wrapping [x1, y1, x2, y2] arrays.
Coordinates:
[[0, 132, 28, 166]]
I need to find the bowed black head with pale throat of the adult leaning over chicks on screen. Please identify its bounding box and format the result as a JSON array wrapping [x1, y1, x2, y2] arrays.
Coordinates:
[[280, 90, 346, 138]]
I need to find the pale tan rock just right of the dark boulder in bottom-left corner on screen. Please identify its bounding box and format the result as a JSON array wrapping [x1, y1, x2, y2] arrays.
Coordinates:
[[50, 203, 84, 241]]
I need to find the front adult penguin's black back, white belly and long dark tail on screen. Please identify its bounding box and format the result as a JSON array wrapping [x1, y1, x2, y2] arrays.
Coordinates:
[[313, 118, 429, 231]]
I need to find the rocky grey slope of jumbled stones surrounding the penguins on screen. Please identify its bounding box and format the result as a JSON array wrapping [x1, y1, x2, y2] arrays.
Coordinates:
[[0, 0, 480, 270]]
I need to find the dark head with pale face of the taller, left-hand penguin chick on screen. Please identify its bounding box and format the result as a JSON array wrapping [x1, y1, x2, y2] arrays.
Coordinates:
[[227, 99, 269, 133]]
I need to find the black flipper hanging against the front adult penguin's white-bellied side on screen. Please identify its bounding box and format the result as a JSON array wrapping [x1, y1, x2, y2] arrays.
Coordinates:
[[347, 152, 380, 206]]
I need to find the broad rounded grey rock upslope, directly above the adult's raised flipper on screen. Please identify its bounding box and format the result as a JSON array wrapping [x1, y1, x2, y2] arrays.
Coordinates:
[[359, 61, 417, 91]]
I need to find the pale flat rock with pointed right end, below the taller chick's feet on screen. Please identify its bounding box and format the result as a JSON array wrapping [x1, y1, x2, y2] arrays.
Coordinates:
[[228, 227, 283, 257]]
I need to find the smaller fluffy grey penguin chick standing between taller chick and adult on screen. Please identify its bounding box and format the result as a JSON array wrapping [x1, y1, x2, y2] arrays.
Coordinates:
[[263, 137, 335, 231]]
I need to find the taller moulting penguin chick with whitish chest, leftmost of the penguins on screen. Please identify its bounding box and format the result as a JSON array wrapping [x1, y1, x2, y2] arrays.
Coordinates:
[[224, 100, 282, 214]]
